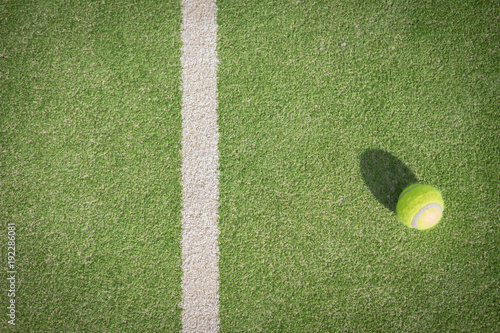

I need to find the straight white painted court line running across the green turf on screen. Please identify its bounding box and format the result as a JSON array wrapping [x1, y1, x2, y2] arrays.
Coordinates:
[[181, 0, 219, 333]]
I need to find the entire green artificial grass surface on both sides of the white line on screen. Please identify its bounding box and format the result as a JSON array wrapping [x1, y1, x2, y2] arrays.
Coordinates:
[[0, 0, 500, 333]]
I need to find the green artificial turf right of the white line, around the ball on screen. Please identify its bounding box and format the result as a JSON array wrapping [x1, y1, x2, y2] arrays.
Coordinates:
[[217, 0, 500, 332]]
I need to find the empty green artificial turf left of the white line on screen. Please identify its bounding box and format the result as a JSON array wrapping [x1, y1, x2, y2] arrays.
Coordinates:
[[0, 0, 182, 332]]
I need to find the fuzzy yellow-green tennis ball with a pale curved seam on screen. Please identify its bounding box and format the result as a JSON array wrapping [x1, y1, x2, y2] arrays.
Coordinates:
[[396, 183, 444, 230]]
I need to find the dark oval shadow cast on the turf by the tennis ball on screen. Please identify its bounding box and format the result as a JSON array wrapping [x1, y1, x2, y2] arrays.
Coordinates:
[[360, 149, 417, 212]]
